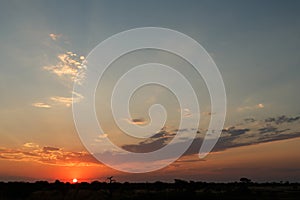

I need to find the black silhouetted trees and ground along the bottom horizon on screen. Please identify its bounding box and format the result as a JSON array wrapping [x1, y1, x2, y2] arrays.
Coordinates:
[[0, 177, 300, 200]]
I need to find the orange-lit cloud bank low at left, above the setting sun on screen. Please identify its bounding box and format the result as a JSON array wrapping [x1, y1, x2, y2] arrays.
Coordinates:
[[0, 142, 101, 166]]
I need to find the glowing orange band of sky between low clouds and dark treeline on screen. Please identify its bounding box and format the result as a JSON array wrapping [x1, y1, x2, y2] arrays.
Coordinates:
[[0, 138, 300, 183]]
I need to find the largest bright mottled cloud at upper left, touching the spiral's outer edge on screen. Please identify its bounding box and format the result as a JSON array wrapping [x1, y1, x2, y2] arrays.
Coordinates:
[[43, 51, 86, 84]]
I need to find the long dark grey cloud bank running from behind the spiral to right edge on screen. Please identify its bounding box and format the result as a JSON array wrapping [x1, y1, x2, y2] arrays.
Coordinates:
[[122, 116, 300, 155]]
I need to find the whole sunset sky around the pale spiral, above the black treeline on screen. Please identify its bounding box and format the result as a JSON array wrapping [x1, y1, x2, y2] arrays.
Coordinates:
[[0, 0, 300, 182]]
